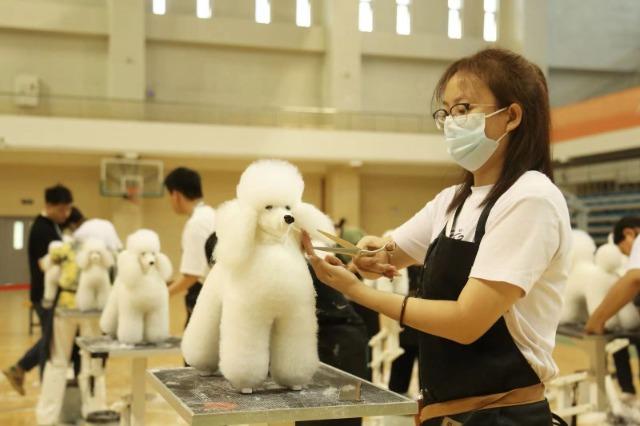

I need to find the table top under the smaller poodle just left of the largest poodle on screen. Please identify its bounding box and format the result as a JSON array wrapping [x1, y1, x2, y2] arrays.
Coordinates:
[[76, 336, 180, 358]]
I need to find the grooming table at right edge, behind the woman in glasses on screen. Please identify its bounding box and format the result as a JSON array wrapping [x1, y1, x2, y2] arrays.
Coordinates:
[[557, 324, 639, 411]]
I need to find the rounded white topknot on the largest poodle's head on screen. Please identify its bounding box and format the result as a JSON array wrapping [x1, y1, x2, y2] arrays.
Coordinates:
[[236, 160, 304, 209]]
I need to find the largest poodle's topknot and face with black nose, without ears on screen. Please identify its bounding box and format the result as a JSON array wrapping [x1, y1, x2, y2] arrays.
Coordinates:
[[236, 160, 304, 237]]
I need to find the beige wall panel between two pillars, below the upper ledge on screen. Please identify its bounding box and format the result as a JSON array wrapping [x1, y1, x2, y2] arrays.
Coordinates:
[[147, 42, 322, 107]]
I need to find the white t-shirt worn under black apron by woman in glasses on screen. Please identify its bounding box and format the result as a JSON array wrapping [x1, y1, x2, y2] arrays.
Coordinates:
[[392, 171, 571, 381]]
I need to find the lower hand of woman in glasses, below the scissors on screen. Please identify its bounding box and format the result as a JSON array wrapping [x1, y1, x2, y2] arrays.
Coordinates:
[[302, 231, 363, 296]]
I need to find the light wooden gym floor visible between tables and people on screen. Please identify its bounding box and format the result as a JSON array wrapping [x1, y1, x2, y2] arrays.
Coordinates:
[[0, 291, 637, 426]]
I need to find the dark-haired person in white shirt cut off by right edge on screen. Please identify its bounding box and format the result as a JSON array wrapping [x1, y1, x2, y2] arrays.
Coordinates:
[[585, 216, 640, 334]]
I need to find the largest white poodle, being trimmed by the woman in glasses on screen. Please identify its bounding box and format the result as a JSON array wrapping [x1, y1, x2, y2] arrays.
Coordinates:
[[182, 160, 334, 393]]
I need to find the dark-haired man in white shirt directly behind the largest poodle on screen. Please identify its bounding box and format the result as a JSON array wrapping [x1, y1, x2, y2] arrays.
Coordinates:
[[164, 167, 215, 323]]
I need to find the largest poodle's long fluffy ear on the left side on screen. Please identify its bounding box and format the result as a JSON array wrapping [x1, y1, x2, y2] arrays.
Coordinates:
[[214, 199, 258, 265]]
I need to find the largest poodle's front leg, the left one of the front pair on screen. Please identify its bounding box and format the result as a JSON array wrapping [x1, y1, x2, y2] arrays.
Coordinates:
[[220, 301, 273, 390]]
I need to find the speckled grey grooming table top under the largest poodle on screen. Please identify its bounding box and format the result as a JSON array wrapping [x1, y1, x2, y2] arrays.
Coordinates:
[[147, 364, 418, 426]]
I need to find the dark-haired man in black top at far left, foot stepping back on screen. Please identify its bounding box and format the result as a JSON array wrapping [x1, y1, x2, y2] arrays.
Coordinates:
[[2, 185, 73, 395]]
